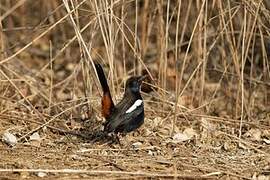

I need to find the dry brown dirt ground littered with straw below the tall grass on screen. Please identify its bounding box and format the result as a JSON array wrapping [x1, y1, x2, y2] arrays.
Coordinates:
[[0, 100, 270, 179]]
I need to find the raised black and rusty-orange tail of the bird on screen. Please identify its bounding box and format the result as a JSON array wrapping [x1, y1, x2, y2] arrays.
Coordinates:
[[95, 63, 114, 119]]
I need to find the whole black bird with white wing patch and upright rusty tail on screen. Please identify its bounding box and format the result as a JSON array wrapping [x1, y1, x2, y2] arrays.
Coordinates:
[[95, 63, 146, 134]]
